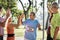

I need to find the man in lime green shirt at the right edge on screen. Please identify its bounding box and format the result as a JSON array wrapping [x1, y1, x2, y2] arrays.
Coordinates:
[[47, 2, 60, 40]]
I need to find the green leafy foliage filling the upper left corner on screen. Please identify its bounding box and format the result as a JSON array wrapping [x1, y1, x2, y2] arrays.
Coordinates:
[[0, 0, 22, 16]]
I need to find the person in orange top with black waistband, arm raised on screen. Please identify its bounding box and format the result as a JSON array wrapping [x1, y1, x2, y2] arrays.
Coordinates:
[[5, 8, 19, 40]]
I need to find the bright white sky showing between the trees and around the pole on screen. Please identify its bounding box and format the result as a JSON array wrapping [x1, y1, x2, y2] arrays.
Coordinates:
[[17, 0, 58, 25]]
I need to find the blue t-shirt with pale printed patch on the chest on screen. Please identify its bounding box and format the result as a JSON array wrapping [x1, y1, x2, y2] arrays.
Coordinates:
[[23, 19, 38, 40]]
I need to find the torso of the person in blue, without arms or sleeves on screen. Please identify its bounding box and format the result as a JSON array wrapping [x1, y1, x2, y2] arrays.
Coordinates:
[[25, 19, 38, 39]]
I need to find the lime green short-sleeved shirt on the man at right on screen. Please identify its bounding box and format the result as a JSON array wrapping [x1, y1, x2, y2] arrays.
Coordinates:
[[51, 13, 60, 37]]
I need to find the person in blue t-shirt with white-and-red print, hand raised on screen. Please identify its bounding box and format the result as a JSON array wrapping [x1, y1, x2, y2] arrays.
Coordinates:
[[20, 12, 41, 40]]
